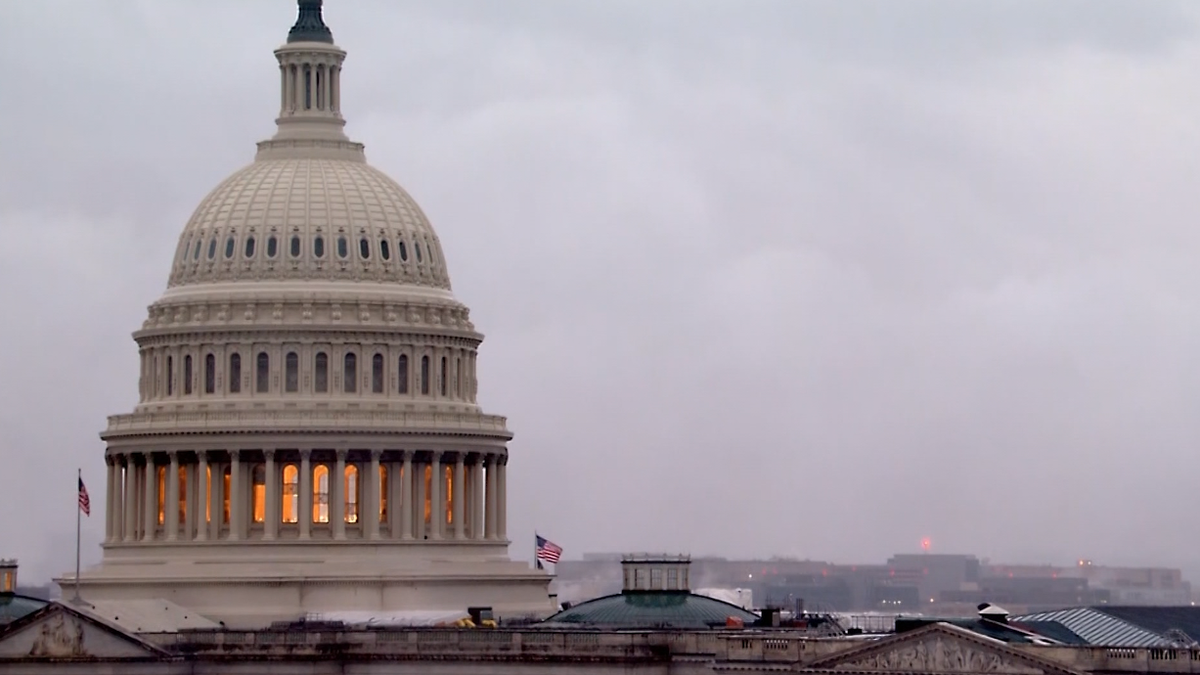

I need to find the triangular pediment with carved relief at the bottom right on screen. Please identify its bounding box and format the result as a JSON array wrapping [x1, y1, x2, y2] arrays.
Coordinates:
[[803, 623, 1078, 675]]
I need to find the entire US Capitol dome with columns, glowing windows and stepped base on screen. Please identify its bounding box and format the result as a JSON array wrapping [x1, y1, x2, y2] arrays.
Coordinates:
[[59, 0, 552, 626]]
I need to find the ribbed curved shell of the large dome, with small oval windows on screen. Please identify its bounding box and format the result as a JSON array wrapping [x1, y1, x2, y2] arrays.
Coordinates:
[[169, 157, 450, 289]]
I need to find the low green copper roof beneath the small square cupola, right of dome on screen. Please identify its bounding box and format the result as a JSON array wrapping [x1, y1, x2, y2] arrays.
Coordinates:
[[545, 591, 758, 628]]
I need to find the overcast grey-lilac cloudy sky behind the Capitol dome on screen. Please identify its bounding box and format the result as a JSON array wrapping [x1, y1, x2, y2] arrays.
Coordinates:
[[0, 0, 1200, 580]]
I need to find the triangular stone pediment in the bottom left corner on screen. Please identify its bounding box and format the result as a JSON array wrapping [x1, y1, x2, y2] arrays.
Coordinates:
[[0, 603, 166, 662]]
